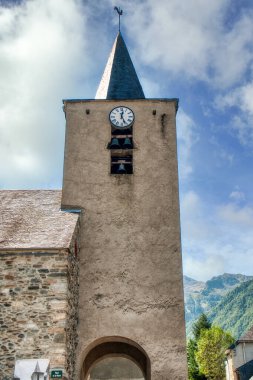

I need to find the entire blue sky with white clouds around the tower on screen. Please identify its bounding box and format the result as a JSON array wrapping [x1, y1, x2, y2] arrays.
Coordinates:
[[0, 0, 253, 281]]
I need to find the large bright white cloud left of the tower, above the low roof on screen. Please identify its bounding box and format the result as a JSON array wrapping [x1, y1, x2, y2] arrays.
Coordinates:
[[0, 0, 90, 188]]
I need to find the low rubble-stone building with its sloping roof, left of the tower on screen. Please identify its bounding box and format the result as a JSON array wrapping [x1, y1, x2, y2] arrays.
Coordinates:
[[0, 190, 79, 380]]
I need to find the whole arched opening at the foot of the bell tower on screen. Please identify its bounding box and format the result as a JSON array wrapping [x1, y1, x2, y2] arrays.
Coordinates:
[[80, 337, 150, 380]]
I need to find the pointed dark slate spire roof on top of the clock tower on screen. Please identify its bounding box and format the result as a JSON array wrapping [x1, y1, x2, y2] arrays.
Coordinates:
[[95, 32, 145, 99]]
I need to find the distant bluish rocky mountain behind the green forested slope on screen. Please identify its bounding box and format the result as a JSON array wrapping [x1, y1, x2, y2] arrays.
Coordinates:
[[184, 273, 253, 335]]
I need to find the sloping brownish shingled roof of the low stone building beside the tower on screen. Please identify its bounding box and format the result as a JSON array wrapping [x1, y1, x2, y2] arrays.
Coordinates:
[[0, 190, 78, 251]]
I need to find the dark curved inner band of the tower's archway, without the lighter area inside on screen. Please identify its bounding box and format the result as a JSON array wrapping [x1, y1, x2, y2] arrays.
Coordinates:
[[80, 336, 150, 380]]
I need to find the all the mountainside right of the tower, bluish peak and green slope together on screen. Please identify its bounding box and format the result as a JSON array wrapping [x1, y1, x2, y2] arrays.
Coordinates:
[[184, 273, 253, 338]]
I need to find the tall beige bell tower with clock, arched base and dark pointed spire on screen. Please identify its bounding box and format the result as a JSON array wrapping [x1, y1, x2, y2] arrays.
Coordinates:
[[62, 27, 187, 380]]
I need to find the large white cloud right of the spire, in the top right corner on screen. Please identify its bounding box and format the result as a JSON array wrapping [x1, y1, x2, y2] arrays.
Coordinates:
[[125, 0, 253, 88]]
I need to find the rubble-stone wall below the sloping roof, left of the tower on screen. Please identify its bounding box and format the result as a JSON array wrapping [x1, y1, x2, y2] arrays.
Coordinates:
[[0, 230, 78, 380]]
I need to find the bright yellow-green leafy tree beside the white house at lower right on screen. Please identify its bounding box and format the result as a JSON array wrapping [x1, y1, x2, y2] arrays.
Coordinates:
[[195, 326, 234, 380]]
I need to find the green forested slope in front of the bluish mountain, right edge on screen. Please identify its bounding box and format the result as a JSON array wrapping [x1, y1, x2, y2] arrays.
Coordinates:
[[208, 280, 253, 339]]
